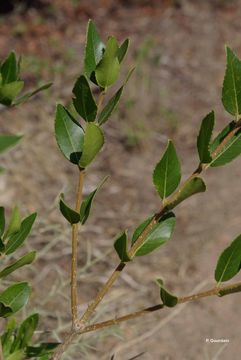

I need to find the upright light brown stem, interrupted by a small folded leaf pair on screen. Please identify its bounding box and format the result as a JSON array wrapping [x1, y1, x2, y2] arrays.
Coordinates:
[[71, 169, 84, 328]]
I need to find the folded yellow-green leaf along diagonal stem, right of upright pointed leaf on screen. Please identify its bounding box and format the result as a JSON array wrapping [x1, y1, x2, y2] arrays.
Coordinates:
[[166, 176, 206, 210]]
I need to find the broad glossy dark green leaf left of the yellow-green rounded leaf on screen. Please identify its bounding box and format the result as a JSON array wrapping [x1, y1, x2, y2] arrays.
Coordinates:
[[55, 104, 84, 164]]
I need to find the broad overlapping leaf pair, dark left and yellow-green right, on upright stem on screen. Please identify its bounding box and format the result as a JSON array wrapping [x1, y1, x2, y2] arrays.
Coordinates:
[[55, 104, 104, 168]]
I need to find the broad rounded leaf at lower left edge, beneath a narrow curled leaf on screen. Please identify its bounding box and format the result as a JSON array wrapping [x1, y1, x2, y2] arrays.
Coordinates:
[[0, 282, 31, 317]]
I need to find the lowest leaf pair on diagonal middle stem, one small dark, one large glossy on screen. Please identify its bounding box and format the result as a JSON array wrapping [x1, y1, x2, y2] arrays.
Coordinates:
[[114, 213, 176, 262]]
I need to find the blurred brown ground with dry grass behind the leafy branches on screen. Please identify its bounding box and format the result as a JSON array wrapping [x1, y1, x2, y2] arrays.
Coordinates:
[[0, 0, 241, 360]]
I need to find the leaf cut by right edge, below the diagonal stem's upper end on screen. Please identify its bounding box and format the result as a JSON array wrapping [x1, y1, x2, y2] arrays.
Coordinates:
[[210, 130, 241, 167]]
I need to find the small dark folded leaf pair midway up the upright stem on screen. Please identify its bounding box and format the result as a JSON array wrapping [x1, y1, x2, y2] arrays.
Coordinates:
[[59, 177, 108, 225]]
